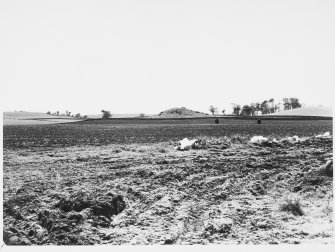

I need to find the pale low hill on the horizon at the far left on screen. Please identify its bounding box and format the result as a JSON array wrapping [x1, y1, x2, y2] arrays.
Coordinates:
[[3, 111, 80, 125]]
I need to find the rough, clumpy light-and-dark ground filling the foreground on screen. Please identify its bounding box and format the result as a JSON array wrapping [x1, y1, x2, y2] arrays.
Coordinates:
[[3, 137, 334, 245]]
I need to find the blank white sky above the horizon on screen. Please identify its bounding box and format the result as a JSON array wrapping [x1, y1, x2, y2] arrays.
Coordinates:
[[0, 0, 335, 114]]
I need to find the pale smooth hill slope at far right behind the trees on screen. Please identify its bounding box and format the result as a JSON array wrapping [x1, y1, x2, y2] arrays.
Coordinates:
[[264, 106, 333, 117]]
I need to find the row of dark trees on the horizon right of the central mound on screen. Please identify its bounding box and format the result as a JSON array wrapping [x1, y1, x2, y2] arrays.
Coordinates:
[[209, 97, 302, 116]]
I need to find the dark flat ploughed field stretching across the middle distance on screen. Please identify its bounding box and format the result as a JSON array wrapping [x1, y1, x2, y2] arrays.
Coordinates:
[[3, 118, 333, 149]]
